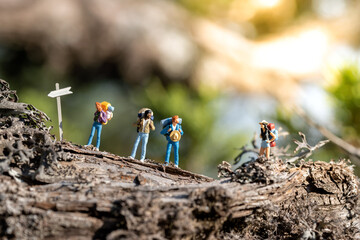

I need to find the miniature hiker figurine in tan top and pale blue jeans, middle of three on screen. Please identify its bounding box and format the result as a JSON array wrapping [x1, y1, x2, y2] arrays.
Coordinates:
[[130, 108, 155, 162]]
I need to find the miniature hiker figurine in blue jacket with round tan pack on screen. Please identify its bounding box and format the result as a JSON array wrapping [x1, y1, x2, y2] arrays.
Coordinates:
[[161, 115, 184, 167]]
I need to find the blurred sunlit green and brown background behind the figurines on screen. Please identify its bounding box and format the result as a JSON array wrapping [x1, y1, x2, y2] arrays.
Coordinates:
[[0, 0, 360, 177]]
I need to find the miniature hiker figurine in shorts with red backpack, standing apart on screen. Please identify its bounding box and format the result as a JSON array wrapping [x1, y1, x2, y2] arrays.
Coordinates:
[[259, 120, 278, 159]]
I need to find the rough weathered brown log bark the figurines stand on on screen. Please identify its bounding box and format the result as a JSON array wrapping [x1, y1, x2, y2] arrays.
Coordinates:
[[0, 80, 360, 239]]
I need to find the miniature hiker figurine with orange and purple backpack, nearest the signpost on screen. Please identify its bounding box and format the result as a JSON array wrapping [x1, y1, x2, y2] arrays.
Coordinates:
[[85, 101, 114, 151]]
